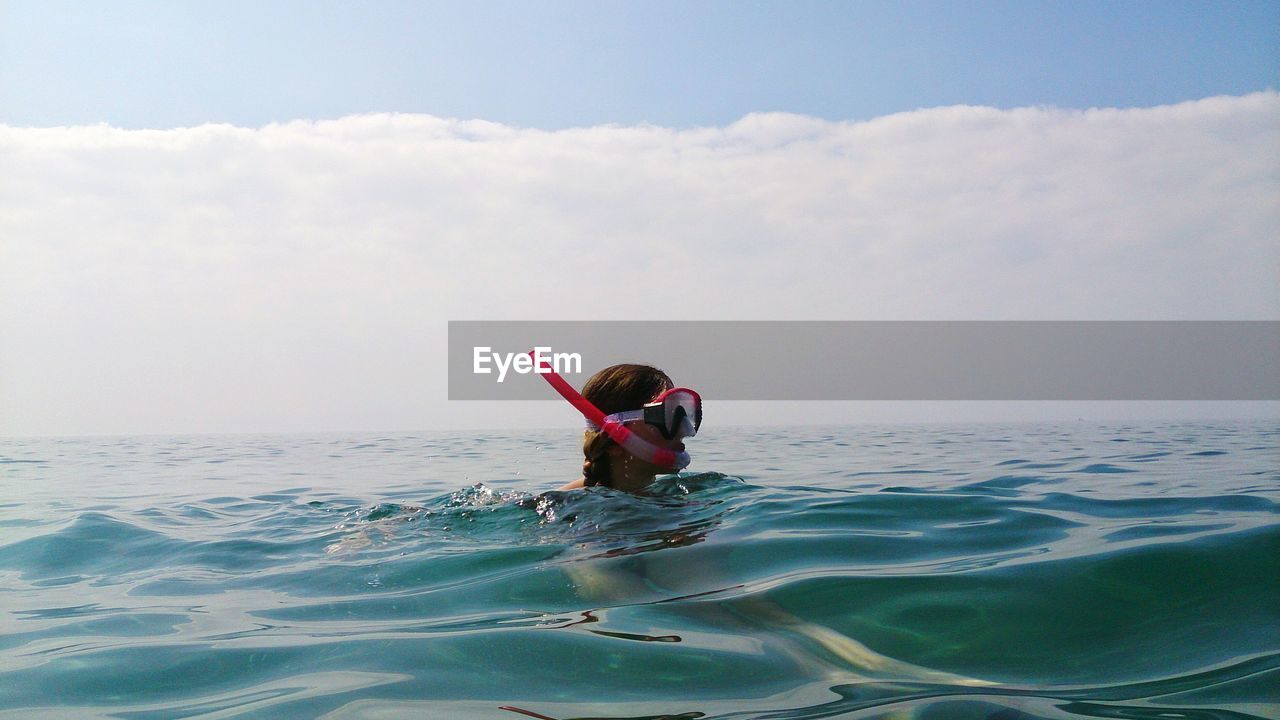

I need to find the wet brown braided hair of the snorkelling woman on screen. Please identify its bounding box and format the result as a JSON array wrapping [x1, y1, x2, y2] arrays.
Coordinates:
[[582, 363, 676, 487]]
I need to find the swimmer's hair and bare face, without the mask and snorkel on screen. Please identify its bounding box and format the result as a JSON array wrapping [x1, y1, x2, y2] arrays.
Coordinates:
[[582, 364, 684, 489]]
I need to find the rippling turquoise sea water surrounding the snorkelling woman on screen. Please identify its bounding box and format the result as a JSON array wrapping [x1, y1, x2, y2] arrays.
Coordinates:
[[0, 423, 1280, 720]]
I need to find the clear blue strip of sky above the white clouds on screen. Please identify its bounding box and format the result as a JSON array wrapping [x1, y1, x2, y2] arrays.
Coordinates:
[[0, 0, 1280, 129]]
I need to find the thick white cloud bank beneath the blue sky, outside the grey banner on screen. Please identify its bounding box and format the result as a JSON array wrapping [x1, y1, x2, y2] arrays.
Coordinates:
[[0, 92, 1280, 434]]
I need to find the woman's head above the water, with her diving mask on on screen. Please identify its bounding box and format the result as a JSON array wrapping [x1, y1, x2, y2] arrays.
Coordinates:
[[557, 364, 703, 492]]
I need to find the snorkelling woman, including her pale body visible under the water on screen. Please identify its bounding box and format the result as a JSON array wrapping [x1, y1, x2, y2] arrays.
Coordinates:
[[543, 365, 991, 685]]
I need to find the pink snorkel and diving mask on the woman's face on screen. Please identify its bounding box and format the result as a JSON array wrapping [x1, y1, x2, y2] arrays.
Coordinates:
[[529, 352, 703, 471]]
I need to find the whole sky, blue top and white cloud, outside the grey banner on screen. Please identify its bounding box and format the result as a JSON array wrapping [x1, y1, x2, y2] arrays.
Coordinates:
[[0, 0, 1280, 436]]
